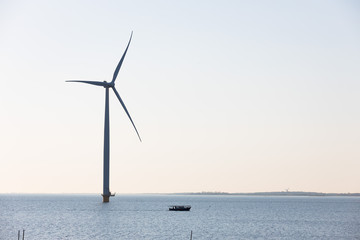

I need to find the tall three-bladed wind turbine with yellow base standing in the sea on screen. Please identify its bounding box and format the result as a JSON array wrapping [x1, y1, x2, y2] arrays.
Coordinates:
[[66, 32, 141, 202]]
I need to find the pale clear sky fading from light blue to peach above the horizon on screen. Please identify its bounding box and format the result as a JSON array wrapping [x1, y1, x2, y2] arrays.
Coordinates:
[[0, 0, 360, 193]]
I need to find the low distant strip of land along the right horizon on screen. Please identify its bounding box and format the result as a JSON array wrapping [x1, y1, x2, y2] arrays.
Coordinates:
[[172, 191, 360, 197]]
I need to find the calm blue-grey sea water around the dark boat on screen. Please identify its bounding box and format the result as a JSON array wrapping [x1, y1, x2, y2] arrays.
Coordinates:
[[0, 194, 360, 240]]
